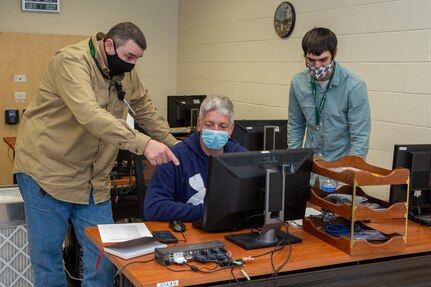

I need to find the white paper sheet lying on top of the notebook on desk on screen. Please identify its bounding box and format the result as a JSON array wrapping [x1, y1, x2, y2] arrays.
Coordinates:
[[97, 222, 153, 243]]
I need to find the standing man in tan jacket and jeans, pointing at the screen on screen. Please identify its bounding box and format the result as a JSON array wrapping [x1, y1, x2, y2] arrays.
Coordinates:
[[14, 22, 179, 287]]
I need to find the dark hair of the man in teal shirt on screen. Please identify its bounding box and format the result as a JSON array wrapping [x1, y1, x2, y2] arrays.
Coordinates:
[[302, 27, 337, 58]]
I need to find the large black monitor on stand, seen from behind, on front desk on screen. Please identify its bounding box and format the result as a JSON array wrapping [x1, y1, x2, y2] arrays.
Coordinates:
[[201, 149, 313, 249]]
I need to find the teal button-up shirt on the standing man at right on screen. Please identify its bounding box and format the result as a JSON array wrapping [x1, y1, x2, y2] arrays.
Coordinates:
[[288, 62, 371, 161]]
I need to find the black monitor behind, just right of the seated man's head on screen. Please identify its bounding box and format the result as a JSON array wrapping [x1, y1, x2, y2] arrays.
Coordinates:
[[232, 120, 287, 151]]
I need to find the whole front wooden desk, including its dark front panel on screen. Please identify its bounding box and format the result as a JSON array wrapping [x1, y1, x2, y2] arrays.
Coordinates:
[[85, 222, 431, 287]]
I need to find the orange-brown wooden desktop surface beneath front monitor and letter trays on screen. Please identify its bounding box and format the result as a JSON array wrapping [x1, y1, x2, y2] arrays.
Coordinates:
[[85, 222, 431, 286]]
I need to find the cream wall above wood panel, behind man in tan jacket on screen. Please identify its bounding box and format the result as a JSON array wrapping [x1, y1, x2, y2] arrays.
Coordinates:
[[0, 0, 178, 116]]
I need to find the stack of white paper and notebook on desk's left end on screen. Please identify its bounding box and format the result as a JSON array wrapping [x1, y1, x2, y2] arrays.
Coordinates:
[[97, 223, 166, 259]]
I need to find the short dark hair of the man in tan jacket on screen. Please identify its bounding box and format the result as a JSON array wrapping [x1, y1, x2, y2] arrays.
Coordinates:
[[104, 22, 147, 50]]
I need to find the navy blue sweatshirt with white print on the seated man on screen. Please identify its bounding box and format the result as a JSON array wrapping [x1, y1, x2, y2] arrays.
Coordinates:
[[144, 132, 247, 221]]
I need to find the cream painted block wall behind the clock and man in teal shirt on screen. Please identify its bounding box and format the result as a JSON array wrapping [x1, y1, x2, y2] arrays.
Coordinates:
[[177, 0, 431, 173]]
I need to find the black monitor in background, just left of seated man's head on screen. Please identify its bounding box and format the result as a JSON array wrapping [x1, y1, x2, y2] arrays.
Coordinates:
[[168, 95, 206, 131]]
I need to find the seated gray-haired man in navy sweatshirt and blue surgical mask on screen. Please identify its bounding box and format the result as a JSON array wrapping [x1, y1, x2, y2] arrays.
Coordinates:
[[144, 96, 247, 221]]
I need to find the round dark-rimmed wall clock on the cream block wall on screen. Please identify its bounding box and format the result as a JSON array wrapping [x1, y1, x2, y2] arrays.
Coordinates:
[[274, 2, 295, 38]]
